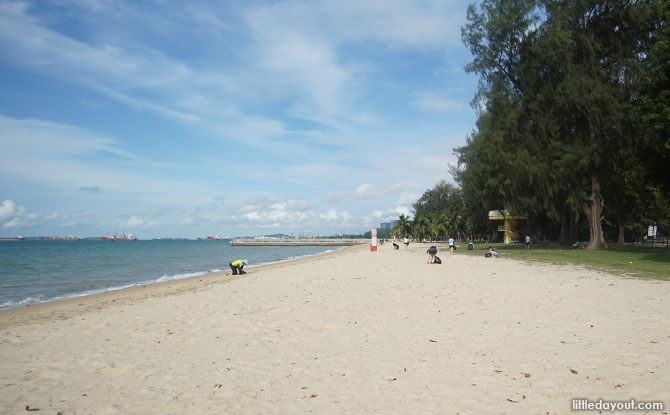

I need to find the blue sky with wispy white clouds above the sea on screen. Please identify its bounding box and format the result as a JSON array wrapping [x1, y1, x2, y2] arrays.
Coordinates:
[[0, 0, 484, 239]]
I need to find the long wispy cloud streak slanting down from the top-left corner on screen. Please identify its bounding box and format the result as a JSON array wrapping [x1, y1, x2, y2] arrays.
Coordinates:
[[0, 2, 233, 122]]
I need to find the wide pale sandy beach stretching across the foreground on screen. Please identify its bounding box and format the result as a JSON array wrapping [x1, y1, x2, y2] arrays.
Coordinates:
[[0, 244, 670, 415]]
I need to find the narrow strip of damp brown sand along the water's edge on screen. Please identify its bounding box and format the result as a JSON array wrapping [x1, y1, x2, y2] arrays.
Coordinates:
[[0, 245, 360, 329]]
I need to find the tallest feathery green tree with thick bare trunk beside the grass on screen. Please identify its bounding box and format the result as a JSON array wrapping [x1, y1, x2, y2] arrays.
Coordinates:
[[458, 0, 667, 248]]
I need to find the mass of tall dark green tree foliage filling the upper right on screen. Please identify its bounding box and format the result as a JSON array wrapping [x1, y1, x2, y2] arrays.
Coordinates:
[[454, 0, 670, 247]]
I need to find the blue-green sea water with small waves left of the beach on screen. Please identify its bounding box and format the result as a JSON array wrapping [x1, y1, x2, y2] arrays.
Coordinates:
[[0, 240, 341, 309]]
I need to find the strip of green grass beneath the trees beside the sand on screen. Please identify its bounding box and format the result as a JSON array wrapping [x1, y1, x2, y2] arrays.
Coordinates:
[[458, 244, 670, 281]]
